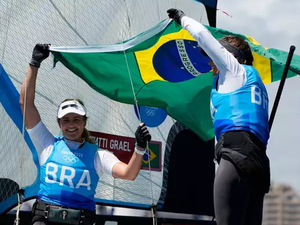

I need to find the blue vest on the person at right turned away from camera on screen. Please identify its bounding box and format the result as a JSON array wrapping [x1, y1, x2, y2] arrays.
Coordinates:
[[210, 65, 269, 144]]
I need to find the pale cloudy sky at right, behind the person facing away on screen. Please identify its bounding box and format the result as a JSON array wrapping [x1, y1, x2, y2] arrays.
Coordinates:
[[217, 0, 300, 195]]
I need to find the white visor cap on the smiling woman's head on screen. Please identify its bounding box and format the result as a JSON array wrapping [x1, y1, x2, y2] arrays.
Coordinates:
[[57, 100, 86, 119]]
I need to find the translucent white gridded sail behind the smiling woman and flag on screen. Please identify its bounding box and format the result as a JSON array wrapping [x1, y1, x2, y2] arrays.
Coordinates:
[[0, 0, 208, 213]]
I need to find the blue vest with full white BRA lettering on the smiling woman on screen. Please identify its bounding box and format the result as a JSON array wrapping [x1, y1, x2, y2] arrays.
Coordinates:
[[37, 137, 99, 211]]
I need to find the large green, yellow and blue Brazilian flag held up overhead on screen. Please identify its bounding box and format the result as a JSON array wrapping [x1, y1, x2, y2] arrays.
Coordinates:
[[50, 20, 300, 141]]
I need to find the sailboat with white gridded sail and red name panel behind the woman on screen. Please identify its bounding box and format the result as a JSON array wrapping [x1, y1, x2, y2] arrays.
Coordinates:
[[0, 0, 216, 224]]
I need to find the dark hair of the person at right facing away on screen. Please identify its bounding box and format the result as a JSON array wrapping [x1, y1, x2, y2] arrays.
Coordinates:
[[221, 35, 253, 66]]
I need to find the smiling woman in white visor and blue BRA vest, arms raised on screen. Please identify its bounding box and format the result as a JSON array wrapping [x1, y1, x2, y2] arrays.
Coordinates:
[[20, 44, 151, 225]]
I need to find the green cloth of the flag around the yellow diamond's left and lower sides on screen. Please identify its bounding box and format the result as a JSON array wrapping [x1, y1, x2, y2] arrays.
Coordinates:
[[52, 21, 214, 141]]
